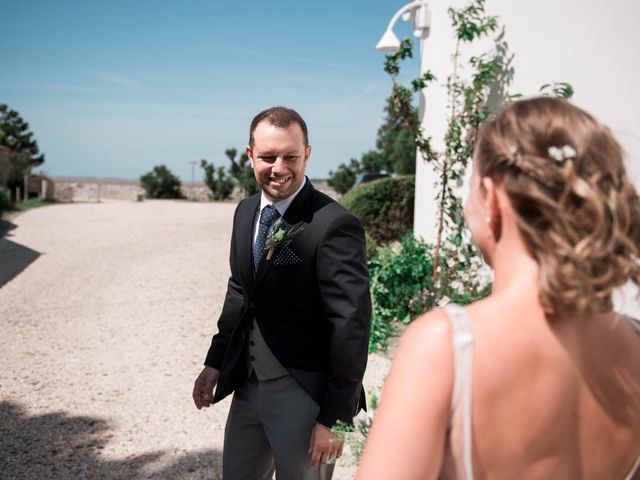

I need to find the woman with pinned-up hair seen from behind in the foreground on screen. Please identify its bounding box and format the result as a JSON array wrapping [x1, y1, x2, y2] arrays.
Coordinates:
[[357, 97, 640, 480]]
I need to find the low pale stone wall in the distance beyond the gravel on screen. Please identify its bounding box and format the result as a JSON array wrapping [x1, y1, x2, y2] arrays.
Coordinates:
[[53, 178, 340, 202]]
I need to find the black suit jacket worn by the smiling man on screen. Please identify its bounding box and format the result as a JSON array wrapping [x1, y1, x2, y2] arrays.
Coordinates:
[[205, 179, 371, 427]]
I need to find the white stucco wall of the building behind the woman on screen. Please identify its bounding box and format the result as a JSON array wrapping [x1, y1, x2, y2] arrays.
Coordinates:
[[414, 0, 640, 314]]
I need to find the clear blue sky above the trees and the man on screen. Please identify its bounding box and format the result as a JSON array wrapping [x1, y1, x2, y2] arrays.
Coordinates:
[[0, 0, 418, 181]]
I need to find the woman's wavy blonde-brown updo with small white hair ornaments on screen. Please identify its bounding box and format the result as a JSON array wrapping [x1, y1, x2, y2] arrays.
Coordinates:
[[475, 97, 640, 315]]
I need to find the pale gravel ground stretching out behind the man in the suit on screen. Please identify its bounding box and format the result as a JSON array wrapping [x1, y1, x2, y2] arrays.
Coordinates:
[[0, 201, 388, 480]]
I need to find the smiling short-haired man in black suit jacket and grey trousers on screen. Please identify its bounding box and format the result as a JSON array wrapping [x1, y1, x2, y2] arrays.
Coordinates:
[[193, 107, 371, 480]]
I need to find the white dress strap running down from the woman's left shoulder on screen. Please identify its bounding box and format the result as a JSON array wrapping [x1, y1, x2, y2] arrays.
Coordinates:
[[444, 304, 473, 480]]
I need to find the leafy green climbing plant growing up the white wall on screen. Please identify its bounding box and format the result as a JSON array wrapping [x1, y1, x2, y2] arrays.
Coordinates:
[[384, 0, 573, 303]]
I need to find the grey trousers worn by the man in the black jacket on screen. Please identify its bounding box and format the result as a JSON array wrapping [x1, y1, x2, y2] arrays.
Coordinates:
[[222, 374, 334, 480]]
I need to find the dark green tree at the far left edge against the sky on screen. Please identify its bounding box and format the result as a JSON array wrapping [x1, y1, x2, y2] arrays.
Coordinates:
[[0, 103, 44, 199]]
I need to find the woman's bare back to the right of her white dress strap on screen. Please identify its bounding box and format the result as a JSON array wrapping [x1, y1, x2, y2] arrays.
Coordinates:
[[460, 292, 640, 479]]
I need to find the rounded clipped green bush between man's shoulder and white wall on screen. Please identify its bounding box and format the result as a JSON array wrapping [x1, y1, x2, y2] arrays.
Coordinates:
[[340, 175, 415, 243]]
